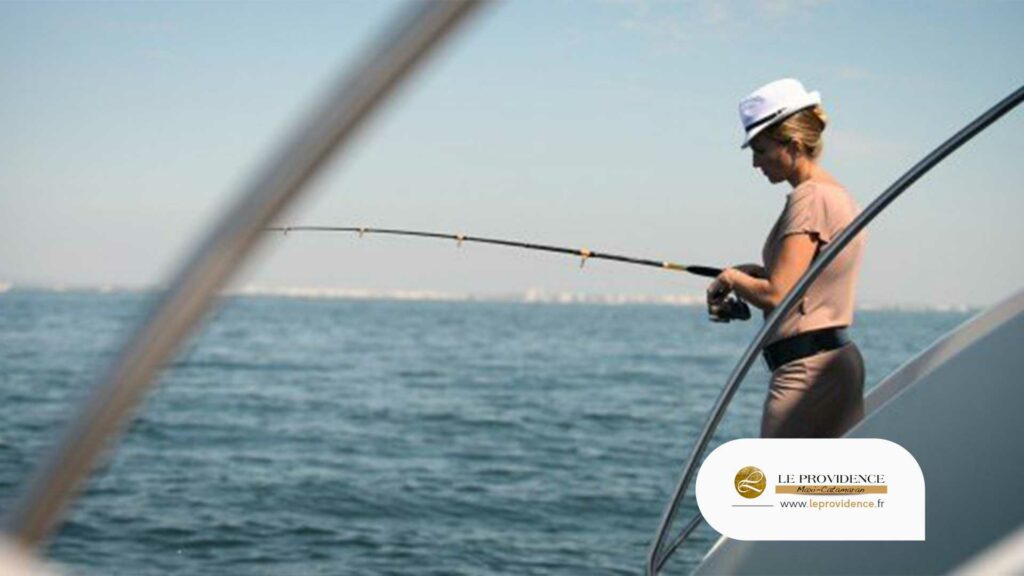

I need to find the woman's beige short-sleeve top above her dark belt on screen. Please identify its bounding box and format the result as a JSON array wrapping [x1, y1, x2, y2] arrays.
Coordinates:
[[761, 180, 865, 341]]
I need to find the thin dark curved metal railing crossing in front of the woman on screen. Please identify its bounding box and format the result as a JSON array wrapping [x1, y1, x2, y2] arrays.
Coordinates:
[[647, 81, 1024, 576]]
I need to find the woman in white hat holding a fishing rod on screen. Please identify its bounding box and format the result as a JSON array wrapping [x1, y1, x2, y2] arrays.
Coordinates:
[[708, 79, 864, 438]]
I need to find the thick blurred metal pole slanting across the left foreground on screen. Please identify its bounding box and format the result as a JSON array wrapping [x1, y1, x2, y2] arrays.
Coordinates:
[[3, 0, 480, 547]]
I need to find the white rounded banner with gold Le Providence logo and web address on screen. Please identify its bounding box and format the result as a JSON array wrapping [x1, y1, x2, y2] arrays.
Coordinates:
[[696, 439, 925, 540]]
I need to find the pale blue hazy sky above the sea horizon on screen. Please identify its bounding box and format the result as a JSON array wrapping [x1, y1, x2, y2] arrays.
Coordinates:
[[0, 0, 1024, 305]]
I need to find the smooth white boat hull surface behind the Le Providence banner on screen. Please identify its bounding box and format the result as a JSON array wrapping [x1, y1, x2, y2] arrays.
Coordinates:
[[694, 291, 1024, 574]]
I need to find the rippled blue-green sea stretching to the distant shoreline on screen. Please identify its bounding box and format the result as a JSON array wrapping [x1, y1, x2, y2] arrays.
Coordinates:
[[0, 288, 975, 576]]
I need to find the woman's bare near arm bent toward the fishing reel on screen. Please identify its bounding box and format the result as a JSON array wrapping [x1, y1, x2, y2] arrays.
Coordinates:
[[708, 234, 817, 313]]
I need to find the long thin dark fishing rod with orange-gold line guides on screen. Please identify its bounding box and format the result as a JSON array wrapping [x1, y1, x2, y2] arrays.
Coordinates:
[[266, 225, 722, 278]]
